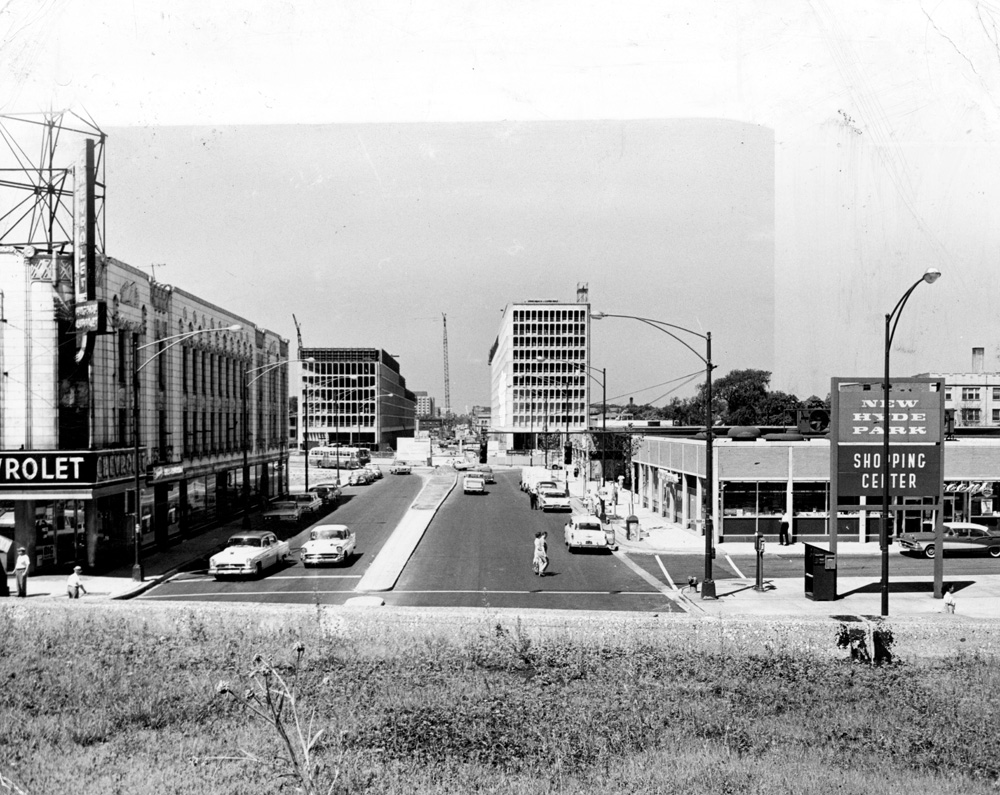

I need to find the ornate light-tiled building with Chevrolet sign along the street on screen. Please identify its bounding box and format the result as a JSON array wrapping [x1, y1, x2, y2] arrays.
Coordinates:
[[0, 246, 288, 571]]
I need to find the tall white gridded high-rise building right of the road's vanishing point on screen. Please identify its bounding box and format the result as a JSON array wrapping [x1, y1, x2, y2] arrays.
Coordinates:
[[489, 301, 590, 450]]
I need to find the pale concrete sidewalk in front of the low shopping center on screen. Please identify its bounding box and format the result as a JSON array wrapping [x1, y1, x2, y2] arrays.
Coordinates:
[[570, 479, 1000, 621]]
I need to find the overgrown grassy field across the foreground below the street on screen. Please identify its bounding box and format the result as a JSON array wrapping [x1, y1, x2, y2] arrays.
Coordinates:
[[0, 603, 1000, 795]]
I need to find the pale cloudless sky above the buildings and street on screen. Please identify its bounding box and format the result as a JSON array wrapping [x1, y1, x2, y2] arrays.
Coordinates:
[[0, 0, 1000, 411]]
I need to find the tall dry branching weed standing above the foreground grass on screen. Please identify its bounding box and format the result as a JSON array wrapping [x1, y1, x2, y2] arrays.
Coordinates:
[[210, 642, 340, 795]]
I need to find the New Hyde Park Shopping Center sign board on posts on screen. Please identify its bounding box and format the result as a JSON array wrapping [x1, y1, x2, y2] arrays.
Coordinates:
[[830, 378, 944, 510]]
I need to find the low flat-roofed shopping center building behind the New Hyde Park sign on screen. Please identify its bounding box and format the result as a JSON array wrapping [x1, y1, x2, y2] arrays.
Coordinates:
[[632, 434, 1000, 544]]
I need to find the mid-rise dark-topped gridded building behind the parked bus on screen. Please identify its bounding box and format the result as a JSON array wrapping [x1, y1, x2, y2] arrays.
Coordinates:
[[298, 348, 416, 450]]
